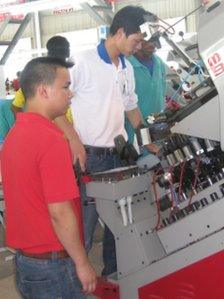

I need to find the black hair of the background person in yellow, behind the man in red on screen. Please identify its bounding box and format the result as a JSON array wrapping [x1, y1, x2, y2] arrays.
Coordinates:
[[46, 35, 70, 60]]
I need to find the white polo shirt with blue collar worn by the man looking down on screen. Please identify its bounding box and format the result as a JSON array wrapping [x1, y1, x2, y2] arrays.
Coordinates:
[[71, 48, 137, 147]]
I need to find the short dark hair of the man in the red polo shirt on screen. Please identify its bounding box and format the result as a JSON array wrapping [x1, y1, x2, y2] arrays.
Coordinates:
[[20, 57, 70, 99]]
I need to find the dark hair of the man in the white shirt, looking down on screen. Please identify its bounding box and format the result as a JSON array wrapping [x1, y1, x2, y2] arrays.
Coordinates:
[[110, 5, 152, 36]]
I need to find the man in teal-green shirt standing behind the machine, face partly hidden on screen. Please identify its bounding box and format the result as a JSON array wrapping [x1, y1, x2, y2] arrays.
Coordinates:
[[125, 40, 166, 143]]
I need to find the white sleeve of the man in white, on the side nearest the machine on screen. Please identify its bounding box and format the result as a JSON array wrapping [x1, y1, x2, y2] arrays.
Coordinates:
[[124, 60, 138, 111]]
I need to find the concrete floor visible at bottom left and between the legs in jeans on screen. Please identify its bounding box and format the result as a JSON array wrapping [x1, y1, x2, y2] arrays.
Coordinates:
[[0, 224, 102, 299]]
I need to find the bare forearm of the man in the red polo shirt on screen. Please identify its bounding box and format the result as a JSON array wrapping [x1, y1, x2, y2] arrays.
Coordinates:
[[50, 201, 88, 267]]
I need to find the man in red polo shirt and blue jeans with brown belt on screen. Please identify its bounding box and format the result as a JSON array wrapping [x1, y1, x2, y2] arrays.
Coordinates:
[[2, 57, 96, 299]]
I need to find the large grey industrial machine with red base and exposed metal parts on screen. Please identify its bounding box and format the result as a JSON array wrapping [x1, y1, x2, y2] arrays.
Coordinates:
[[87, 1, 224, 299]]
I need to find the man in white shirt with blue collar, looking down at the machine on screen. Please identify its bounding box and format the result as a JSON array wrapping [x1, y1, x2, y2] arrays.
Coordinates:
[[55, 6, 157, 275]]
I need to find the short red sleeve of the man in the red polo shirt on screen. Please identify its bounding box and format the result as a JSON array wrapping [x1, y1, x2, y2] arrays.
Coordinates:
[[40, 137, 79, 203]]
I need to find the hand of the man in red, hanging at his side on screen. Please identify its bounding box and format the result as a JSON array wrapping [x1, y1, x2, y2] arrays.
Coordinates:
[[76, 262, 97, 294]]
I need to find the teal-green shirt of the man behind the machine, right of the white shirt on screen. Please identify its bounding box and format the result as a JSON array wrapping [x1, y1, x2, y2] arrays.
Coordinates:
[[125, 54, 166, 143]]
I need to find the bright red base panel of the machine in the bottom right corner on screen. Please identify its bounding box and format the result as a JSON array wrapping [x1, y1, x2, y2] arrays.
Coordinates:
[[138, 251, 224, 299]]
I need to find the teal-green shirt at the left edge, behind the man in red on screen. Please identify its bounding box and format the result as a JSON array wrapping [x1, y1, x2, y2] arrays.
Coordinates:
[[0, 100, 15, 139]]
